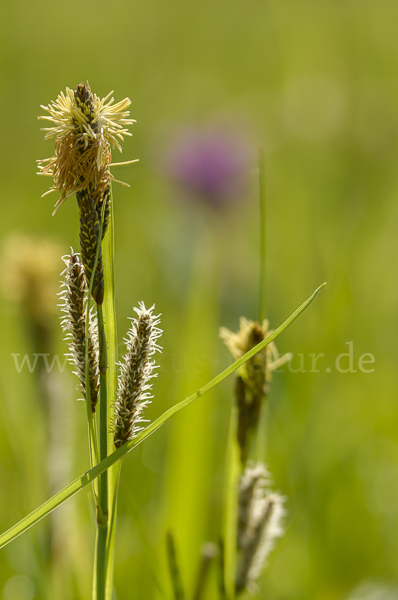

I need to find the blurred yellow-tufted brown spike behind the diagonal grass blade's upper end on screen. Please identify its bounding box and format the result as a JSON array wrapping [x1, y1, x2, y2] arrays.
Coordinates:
[[220, 317, 291, 464]]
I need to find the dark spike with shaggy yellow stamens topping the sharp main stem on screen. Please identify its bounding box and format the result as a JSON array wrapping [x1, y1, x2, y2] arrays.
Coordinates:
[[38, 83, 134, 304]]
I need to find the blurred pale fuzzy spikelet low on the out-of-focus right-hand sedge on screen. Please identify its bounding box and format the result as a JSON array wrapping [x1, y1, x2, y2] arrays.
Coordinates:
[[236, 464, 285, 593]]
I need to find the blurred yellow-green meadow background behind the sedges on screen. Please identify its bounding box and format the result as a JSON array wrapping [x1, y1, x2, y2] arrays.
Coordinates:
[[0, 0, 398, 600]]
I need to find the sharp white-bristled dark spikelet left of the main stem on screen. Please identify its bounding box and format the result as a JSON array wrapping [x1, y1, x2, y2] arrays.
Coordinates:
[[60, 251, 99, 412]]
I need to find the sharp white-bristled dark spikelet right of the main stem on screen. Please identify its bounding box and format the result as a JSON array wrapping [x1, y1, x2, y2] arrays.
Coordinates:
[[114, 302, 162, 448]]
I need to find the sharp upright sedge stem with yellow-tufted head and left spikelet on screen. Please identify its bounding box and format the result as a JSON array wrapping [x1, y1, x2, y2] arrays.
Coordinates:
[[38, 82, 135, 600]]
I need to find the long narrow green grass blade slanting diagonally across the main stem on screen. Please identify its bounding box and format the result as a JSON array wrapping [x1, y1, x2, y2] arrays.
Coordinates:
[[0, 283, 326, 548]]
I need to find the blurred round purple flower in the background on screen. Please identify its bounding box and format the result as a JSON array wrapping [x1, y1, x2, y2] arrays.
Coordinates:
[[165, 127, 250, 209]]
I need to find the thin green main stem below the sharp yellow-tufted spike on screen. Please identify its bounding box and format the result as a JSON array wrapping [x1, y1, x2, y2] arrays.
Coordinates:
[[95, 305, 108, 600]]
